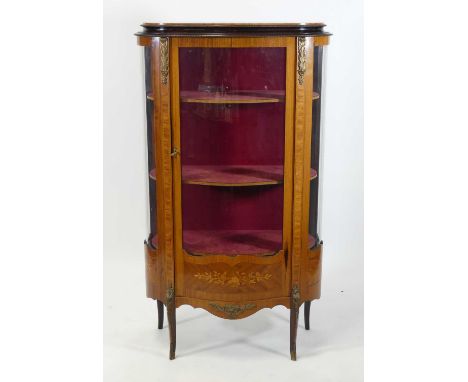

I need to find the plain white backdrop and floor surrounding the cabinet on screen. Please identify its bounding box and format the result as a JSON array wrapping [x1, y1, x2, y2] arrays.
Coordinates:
[[104, 0, 363, 382]]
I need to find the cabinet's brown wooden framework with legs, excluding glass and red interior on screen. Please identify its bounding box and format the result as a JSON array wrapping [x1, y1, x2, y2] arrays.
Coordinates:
[[138, 24, 329, 360]]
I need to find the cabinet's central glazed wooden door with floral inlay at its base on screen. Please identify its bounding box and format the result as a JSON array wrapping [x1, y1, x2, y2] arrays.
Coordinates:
[[170, 38, 295, 297]]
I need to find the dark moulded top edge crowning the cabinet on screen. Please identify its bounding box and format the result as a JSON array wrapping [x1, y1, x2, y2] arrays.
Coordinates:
[[136, 23, 330, 36]]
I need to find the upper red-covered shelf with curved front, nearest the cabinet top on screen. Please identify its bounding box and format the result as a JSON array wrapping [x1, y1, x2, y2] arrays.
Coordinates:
[[146, 90, 320, 104]]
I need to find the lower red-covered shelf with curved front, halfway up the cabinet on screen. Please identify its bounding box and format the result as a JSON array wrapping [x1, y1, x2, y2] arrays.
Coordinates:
[[150, 165, 317, 187]]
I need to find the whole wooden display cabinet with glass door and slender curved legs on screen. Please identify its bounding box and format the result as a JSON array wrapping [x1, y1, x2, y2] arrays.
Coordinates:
[[137, 23, 329, 360]]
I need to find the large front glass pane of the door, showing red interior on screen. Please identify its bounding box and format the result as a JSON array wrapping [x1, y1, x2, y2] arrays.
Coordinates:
[[179, 48, 286, 256]]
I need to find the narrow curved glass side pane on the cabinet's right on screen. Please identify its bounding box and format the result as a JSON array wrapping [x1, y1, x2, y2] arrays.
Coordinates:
[[309, 46, 324, 245]]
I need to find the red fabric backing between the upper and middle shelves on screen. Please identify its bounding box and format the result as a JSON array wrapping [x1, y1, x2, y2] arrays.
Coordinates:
[[180, 103, 284, 166]]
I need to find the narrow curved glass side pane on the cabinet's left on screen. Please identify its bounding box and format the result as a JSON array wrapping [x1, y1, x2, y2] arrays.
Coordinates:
[[144, 47, 158, 247]]
